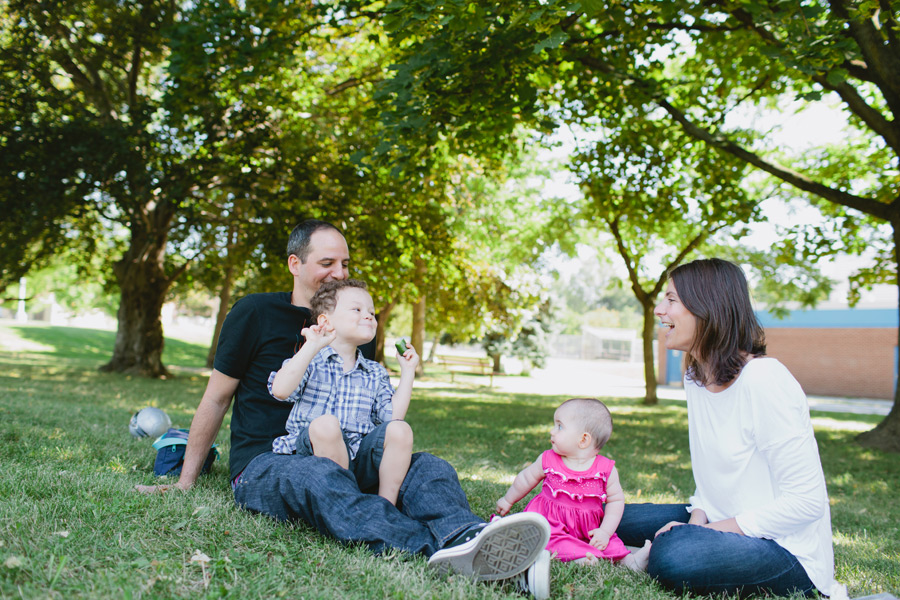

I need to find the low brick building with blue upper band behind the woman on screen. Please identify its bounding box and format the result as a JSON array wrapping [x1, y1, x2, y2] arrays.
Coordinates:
[[657, 308, 898, 400]]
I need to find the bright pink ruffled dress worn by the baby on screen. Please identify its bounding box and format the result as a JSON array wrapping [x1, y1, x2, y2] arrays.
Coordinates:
[[525, 450, 628, 561]]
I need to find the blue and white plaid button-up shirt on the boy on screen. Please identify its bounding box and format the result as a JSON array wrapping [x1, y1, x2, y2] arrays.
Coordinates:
[[268, 346, 394, 460]]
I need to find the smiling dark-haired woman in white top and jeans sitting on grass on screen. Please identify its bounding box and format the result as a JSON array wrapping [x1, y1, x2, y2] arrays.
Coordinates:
[[618, 259, 846, 597]]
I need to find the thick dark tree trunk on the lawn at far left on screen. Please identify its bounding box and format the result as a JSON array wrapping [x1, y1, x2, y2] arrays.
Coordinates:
[[100, 200, 174, 377]]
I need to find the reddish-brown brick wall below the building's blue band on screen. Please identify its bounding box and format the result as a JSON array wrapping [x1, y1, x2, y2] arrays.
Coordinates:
[[766, 327, 897, 399]]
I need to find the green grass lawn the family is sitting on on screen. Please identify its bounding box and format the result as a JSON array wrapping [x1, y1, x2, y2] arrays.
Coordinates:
[[0, 324, 900, 600]]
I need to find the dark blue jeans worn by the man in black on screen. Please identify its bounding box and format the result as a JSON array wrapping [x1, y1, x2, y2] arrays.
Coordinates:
[[234, 452, 484, 556]]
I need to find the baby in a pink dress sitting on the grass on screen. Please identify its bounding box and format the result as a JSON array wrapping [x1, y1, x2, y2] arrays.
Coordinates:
[[497, 398, 650, 571]]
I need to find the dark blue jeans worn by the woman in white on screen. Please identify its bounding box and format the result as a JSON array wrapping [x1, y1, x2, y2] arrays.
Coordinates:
[[616, 504, 815, 596]]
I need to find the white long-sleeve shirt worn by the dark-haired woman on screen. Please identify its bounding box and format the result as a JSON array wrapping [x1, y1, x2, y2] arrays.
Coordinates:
[[684, 358, 835, 595]]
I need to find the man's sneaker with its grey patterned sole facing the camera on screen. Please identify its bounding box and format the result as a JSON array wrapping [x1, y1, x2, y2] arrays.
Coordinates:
[[428, 512, 550, 582]]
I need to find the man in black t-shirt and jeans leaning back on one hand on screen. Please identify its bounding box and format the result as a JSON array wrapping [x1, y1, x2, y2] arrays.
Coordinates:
[[138, 220, 550, 585]]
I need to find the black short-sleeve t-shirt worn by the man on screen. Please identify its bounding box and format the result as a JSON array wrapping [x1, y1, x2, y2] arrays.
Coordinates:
[[215, 292, 375, 479]]
